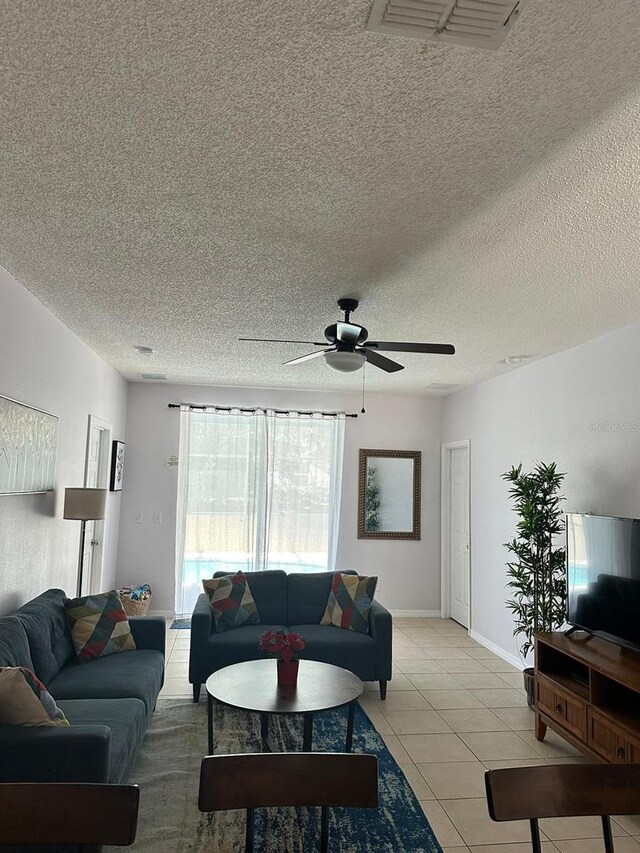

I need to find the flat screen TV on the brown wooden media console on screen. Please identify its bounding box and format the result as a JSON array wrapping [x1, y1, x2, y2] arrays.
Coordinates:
[[566, 513, 640, 650]]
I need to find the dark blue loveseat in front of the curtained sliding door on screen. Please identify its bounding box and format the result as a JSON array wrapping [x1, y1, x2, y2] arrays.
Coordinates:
[[189, 571, 392, 702]]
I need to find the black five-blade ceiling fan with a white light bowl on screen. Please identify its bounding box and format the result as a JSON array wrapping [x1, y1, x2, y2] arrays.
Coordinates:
[[238, 298, 455, 373]]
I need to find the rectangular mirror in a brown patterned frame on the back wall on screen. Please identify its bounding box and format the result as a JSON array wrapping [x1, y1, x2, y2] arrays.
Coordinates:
[[358, 450, 422, 539]]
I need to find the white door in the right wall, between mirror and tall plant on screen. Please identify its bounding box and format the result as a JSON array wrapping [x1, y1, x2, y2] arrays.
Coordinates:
[[448, 446, 471, 628]]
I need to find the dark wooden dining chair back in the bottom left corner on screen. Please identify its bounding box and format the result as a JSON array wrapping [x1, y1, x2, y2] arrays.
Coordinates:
[[0, 782, 140, 853]]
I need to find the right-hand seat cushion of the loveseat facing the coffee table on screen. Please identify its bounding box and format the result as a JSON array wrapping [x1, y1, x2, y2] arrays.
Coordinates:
[[289, 625, 377, 680]]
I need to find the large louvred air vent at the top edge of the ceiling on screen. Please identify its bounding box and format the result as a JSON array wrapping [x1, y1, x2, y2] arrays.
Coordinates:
[[367, 0, 525, 50]]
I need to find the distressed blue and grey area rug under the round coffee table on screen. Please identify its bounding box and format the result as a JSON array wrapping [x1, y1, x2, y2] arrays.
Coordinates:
[[117, 699, 442, 853]]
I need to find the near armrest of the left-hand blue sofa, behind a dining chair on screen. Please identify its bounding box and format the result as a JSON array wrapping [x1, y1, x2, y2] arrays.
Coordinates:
[[0, 726, 111, 782]]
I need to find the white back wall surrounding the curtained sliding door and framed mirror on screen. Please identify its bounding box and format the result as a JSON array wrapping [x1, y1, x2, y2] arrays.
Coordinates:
[[118, 383, 442, 611]]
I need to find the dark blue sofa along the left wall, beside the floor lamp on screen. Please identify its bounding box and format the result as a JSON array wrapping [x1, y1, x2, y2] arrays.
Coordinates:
[[0, 589, 165, 783]]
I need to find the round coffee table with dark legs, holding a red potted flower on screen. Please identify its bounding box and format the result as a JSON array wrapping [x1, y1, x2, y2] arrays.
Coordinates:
[[206, 658, 363, 755]]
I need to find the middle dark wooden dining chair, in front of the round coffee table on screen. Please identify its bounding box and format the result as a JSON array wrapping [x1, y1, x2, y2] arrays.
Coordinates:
[[198, 752, 378, 853]]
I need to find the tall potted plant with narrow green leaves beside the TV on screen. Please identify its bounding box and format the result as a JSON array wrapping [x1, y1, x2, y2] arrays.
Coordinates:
[[502, 462, 567, 706]]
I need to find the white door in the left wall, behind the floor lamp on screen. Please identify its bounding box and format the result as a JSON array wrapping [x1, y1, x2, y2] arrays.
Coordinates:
[[80, 415, 111, 595]]
